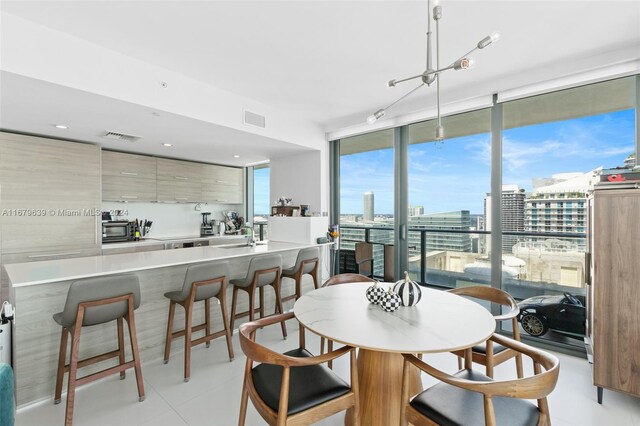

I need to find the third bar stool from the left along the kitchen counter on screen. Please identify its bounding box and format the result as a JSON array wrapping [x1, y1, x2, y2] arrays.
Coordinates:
[[226, 254, 287, 338]]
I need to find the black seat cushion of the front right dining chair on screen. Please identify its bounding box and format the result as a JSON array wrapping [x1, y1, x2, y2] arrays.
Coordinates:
[[411, 370, 540, 426]]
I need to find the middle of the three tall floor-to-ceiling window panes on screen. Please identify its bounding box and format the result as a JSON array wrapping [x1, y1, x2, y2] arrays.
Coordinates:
[[407, 109, 491, 287]]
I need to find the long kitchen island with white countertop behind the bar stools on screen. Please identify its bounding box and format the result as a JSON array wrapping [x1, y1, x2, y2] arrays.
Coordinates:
[[5, 242, 312, 405]]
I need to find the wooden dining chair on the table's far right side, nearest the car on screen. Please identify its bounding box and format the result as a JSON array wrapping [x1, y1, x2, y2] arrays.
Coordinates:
[[449, 286, 522, 377]]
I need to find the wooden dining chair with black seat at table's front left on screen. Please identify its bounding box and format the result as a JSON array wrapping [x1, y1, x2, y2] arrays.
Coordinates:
[[238, 312, 360, 426]]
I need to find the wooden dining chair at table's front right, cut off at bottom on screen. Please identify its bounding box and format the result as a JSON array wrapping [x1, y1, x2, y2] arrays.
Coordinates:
[[400, 334, 560, 426]]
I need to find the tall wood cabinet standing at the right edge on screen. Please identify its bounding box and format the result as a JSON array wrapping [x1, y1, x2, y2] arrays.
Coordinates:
[[585, 189, 640, 403]]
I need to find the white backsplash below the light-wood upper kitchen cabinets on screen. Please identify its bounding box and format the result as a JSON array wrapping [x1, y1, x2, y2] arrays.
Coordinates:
[[102, 201, 244, 238]]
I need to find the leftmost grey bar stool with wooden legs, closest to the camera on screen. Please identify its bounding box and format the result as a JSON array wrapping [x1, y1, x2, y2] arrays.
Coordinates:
[[53, 275, 144, 425]]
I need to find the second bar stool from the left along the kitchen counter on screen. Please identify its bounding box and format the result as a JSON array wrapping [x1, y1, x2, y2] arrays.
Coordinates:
[[164, 262, 233, 382]]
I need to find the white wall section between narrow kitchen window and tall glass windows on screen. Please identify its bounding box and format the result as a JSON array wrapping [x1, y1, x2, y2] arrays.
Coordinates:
[[269, 149, 329, 215]]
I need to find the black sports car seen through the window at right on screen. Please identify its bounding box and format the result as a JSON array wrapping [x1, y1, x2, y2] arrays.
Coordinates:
[[518, 293, 586, 337]]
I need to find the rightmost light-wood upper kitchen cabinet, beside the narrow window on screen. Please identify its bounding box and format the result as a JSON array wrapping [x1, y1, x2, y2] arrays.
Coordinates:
[[202, 164, 244, 204]]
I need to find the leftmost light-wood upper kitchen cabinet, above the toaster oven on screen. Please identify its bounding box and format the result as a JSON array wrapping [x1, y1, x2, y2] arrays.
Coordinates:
[[102, 151, 157, 202]]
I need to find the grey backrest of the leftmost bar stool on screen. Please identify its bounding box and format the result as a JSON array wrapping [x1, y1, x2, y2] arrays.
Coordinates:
[[62, 274, 140, 327]]
